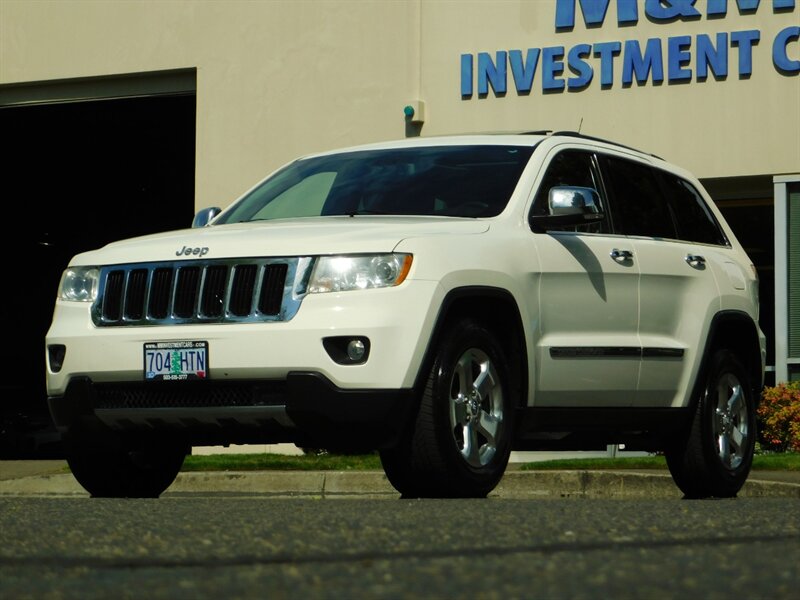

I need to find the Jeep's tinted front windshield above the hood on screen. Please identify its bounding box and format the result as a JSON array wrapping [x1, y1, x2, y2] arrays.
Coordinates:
[[215, 146, 533, 224]]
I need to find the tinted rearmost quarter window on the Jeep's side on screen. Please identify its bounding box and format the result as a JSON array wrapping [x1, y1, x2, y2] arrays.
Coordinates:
[[659, 171, 728, 246]]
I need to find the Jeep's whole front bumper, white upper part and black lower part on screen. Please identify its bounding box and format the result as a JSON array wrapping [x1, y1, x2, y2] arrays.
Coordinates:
[[46, 281, 441, 449]]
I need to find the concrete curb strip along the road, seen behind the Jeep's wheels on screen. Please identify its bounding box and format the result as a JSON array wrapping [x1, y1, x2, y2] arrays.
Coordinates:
[[0, 460, 800, 499]]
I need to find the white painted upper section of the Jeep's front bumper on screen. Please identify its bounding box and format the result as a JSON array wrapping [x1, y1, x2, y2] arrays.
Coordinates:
[[46, 281, 442, 396]]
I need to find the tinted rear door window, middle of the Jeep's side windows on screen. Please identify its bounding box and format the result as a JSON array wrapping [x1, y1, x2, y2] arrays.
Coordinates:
[[600, 156, 676, 239]]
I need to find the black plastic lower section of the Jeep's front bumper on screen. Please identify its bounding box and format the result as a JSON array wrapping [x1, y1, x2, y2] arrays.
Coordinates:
[[48, 372, 416, 449]]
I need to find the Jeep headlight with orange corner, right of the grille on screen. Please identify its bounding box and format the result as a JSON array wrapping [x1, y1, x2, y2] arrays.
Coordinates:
[[308, 254, 412, 294]]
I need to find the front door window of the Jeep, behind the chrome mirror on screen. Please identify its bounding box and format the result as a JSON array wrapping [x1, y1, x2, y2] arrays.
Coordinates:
[[532, 150, 609, 233]]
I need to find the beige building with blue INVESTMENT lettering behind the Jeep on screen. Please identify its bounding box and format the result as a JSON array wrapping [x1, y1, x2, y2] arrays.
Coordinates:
[[0, 0, 800, 383]]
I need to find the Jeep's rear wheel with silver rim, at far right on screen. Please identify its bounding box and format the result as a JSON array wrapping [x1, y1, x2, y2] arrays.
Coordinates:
[[665, 350, 756, 498]]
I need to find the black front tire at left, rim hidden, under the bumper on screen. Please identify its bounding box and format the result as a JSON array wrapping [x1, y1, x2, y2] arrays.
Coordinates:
[[67, 440, 189, 498]]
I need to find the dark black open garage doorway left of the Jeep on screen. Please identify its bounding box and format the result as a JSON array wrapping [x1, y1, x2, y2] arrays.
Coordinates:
[[0, 94, 195, 457]]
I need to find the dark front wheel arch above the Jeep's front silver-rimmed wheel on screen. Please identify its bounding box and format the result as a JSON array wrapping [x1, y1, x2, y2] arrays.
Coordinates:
[[414, 286, 528, 406]]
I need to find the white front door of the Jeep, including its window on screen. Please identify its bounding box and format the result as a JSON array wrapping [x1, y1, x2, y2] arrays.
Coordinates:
[[531, 149, 640, 407]]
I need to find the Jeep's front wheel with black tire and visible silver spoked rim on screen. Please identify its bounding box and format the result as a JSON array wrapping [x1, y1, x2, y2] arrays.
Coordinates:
[[380, 319, 514, 498]]
